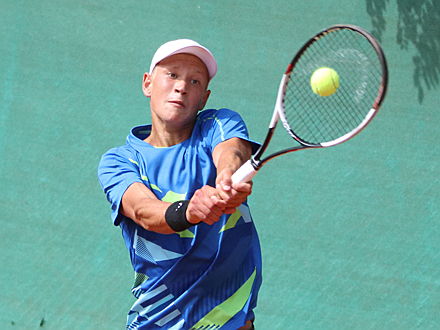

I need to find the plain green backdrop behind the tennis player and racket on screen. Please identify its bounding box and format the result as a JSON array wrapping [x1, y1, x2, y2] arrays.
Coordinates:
[[0, 0, 440, 329]]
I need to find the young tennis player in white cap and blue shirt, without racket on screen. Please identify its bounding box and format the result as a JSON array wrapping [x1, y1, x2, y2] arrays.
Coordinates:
[[98, 39, 261, 329]]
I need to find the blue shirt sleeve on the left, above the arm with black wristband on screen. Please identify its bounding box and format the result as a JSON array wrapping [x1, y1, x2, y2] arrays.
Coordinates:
[[98, 147, 143, 226]]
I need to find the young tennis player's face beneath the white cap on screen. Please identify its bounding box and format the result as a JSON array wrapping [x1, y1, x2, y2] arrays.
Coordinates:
[[142, 54, 210, 128]]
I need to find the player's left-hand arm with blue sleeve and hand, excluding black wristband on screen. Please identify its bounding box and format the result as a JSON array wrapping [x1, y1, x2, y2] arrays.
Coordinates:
[[98, 148, 229, 234]]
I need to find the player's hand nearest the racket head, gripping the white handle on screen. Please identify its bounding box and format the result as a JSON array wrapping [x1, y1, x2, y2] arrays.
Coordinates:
[[216, 168, 252, 214]]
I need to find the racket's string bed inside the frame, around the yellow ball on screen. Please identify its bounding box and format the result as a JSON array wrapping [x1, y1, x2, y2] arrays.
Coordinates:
[[284, 29, 382, 144]]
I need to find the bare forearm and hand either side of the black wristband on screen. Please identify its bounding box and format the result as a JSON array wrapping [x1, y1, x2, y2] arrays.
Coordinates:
[[121, 182, 226, 234]]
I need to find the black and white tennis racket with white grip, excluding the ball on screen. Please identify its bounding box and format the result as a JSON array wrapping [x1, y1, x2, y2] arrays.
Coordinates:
[[232, 25, 388, 183]]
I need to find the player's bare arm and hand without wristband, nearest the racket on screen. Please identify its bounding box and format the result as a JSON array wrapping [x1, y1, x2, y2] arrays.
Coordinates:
[[212, 138, 252, 213]]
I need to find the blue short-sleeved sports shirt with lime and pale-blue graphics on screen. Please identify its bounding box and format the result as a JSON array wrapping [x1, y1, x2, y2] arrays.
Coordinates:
[[98, 109, 261, 329]]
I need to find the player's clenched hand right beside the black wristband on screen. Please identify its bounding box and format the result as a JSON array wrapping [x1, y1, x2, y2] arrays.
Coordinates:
[[186, 186, 226, 225]]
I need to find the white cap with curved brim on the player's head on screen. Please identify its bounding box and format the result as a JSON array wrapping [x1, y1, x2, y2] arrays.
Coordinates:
[[150, 39, 217, 79]]
